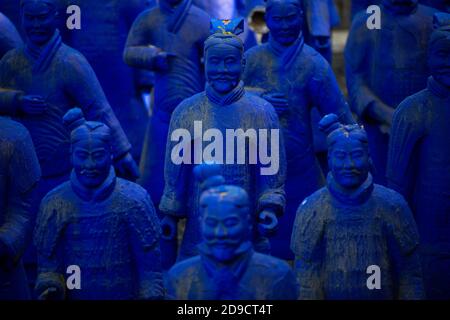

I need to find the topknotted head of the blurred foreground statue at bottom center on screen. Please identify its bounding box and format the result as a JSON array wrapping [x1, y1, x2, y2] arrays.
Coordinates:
[[195, 164, 252, 263]]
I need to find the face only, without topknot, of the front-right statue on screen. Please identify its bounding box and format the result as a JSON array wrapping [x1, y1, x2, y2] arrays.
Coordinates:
[[328, 138, 370, 189]]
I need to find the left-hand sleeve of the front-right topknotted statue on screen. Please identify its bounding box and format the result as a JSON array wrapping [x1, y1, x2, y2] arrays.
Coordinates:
[[291, 197, 326, 300]]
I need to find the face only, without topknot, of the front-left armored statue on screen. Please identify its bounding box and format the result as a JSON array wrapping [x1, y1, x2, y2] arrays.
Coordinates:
[[72, 136, 112, 188]]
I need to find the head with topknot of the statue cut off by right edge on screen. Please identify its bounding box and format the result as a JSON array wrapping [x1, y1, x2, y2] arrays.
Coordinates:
[[428, 13, 450, 87]]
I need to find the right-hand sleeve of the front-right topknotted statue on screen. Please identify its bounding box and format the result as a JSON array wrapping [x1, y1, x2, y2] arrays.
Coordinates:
[[385, 194, 425, 300]]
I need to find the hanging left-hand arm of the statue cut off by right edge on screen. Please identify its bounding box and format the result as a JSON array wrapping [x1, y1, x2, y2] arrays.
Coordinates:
[[386, 100, 423, 201]]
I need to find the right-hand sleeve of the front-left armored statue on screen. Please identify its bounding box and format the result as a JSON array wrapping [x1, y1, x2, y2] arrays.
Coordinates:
[[127, 194, 164, 299]]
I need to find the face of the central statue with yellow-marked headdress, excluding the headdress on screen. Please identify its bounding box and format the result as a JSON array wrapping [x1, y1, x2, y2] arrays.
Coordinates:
[[205, 44, 244, 94]]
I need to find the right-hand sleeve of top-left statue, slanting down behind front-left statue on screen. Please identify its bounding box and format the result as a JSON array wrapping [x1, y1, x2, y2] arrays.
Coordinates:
[[66, 55, 131, 159]]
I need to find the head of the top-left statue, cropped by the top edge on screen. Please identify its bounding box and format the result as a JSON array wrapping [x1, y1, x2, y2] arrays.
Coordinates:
[[20, 0, 58, 46]]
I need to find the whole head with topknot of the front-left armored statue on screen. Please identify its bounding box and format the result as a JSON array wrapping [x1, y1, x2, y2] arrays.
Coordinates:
[[63, 108, 113, 189]]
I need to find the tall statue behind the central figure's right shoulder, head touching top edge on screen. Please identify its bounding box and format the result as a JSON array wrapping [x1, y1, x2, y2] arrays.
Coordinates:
[[243, 0, 354, 260]]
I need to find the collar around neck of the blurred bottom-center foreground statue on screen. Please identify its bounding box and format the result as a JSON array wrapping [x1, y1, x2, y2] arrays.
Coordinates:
[[198, 241, 254, 291]]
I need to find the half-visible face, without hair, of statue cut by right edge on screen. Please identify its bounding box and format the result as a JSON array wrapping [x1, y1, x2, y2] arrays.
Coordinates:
[[428, 39, 450, 87]]
